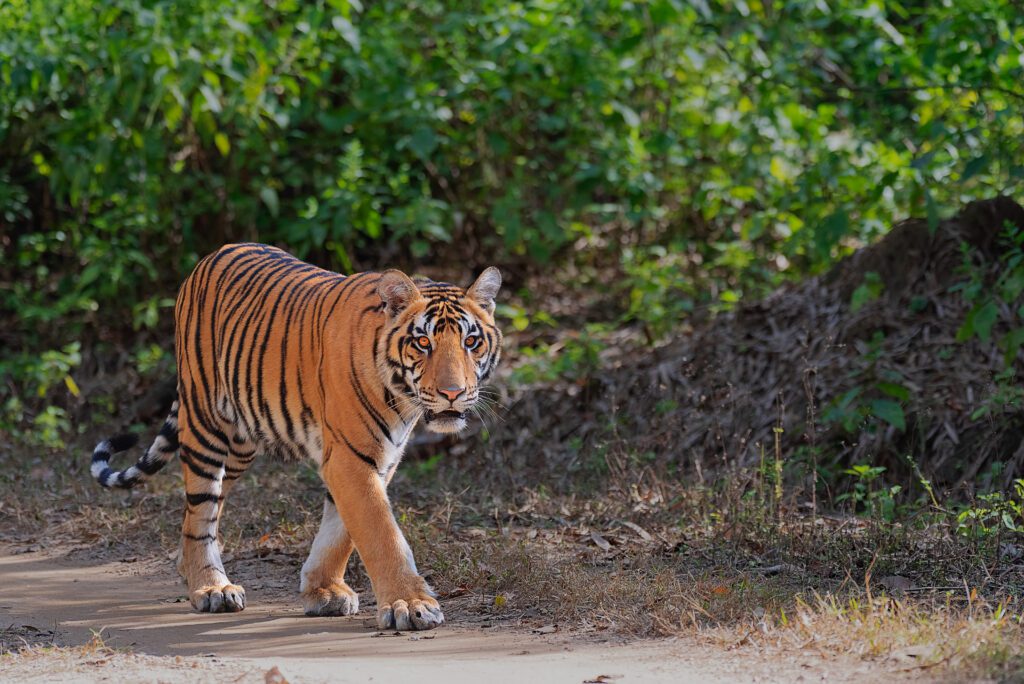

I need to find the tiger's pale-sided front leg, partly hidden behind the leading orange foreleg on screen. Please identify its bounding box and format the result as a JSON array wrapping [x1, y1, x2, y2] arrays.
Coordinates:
[[299, 495, 359, 615]]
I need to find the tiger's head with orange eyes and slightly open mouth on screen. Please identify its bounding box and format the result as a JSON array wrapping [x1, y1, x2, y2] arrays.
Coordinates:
[[377, 266, 502, 432]]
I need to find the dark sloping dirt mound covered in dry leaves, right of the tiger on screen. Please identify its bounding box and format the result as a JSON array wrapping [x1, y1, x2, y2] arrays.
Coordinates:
[[482, 198, 1024, 497]]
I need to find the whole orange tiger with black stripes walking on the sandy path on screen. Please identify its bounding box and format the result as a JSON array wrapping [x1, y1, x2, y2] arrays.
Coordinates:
[[90, 243, 502, 630]]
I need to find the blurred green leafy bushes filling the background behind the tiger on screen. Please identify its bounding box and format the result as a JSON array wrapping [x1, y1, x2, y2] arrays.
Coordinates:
[[0, 0, 1024, 505]]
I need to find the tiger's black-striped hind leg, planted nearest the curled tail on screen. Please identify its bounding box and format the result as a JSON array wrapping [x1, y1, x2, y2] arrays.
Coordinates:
[[178, 414, 246, 612]]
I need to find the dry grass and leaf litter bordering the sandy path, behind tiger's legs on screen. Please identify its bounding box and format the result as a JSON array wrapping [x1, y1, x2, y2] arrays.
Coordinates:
[[0, 428, 1024, 679]]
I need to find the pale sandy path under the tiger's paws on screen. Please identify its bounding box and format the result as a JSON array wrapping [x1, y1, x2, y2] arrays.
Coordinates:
[[0, 548, 913, 684]]
